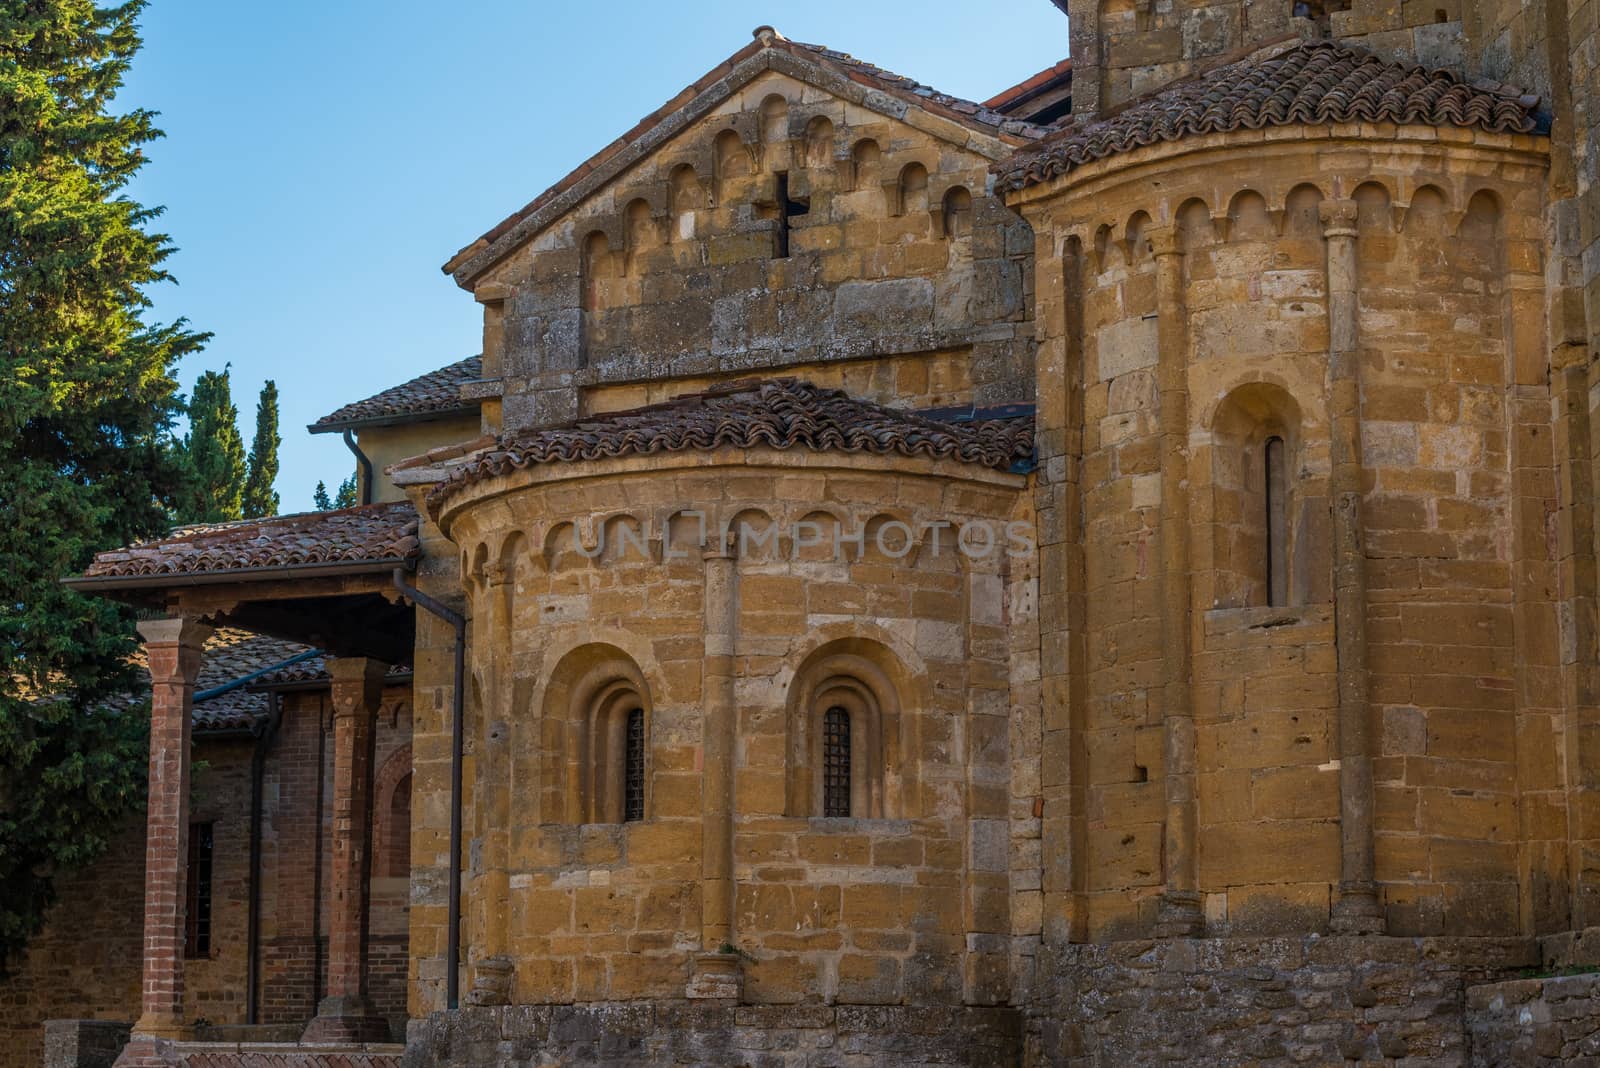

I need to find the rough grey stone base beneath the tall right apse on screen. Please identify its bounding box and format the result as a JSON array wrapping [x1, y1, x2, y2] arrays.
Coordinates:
[[1027, 935, 1539, 1068]]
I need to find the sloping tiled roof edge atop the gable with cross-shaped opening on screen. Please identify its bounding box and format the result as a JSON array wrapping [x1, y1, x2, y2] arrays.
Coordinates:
[[443, 26, 1048, 288]]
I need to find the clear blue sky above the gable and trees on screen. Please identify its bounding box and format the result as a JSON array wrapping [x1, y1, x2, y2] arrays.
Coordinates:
[[118, 0, 1067, 512]]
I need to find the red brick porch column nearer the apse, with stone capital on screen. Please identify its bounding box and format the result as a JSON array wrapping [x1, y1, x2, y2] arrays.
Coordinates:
[[304, 657, 389, 1042]]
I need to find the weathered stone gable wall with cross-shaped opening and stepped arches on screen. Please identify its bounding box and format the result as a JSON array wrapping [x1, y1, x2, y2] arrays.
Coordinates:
[[475, 72, 1032, 428]]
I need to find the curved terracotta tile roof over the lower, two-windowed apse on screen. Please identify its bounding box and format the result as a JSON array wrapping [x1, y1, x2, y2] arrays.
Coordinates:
[[427, 379, 1034, 510]]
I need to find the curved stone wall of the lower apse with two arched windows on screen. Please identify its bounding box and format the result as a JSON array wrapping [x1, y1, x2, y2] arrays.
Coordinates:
[[419, 457, 1037, 1004]]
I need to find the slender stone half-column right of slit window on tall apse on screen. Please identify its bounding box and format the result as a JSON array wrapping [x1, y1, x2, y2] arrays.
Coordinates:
[[1322, 200, 1384, 934]]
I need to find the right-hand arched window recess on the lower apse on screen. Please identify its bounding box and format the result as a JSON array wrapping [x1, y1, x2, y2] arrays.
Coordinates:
[[786, 638, 918, 819]]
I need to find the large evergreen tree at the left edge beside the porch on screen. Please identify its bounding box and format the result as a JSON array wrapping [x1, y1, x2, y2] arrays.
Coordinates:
[[0, 0, 205, 967]]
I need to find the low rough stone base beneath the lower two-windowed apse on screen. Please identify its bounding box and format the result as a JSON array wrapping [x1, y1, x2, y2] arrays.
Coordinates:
[[402, 1001, 1022, 1068]]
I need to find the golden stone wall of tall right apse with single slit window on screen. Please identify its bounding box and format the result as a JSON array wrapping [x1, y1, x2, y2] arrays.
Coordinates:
[[1022, 131, 1548, 940]]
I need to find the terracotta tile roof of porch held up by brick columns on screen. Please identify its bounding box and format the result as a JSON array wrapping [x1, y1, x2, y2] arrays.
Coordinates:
[[85, 500, 421, 579]]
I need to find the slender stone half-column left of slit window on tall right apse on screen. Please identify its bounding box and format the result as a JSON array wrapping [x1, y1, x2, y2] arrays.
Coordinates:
[[1150, 227, 1205, 938]]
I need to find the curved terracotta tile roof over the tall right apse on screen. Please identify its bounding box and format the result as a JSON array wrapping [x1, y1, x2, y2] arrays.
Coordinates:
[[994, 42, 1538, 190]]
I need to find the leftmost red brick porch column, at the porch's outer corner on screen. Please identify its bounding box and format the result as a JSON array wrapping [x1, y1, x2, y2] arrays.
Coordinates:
[[117, 619, 211, 1068]]
